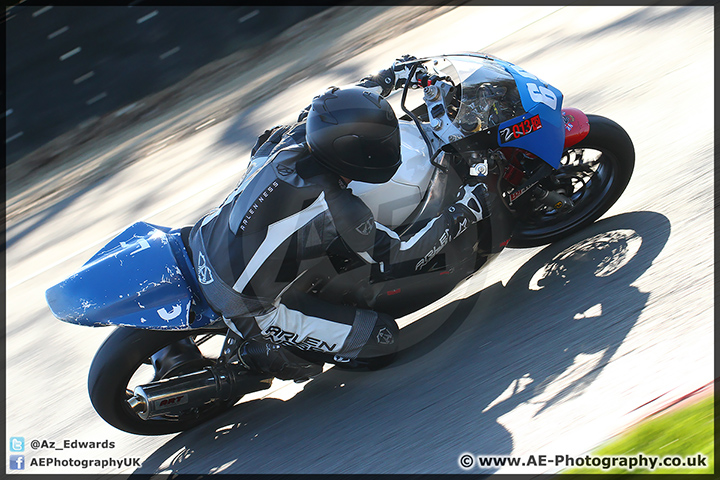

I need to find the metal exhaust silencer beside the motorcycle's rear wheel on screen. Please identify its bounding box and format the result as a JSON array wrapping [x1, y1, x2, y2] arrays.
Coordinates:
[[127, 366, 272, 420]]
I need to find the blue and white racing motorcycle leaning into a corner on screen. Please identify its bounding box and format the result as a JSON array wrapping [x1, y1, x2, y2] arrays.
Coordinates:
[[46, 53, 635, 435]]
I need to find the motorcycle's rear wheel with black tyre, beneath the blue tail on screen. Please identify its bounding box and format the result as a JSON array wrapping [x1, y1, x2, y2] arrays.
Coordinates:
[[88, 327, 232, 435]]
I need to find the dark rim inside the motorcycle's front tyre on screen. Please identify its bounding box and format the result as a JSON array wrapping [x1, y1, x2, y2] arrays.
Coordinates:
[[519, 148, 618, 237]]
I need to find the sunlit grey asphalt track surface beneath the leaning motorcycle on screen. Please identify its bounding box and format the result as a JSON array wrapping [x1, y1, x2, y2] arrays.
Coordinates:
[[6, 7, 714, 474]]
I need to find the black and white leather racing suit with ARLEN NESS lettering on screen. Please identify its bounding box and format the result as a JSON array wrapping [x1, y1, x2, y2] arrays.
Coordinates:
[[190, 65, 486, 370]]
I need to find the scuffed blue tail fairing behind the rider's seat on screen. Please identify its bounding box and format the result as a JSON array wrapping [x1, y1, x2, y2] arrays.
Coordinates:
[[45, 222, 218, 330]]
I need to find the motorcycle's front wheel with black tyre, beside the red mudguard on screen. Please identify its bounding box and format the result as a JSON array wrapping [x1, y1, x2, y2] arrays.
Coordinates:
[[509, 115, 635, 248]]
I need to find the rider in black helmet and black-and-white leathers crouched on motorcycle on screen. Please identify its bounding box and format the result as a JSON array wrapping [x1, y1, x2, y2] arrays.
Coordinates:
[[189, 56, 489, 381]]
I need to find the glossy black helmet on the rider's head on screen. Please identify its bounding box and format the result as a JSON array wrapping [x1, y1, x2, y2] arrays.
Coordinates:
[[305, 87, 401, 183]]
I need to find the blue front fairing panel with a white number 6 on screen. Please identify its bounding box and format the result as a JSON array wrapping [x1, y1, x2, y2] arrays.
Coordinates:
[[495, 59, 565, 168]]
